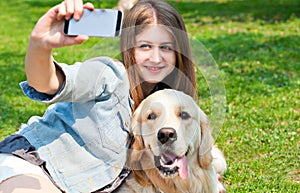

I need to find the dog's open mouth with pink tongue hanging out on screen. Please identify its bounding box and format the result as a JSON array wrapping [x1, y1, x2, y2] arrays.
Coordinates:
[[154, 153, 188, 179]]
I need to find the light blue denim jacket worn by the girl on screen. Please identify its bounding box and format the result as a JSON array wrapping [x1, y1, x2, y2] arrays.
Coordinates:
[[18, 57, 132, 192]]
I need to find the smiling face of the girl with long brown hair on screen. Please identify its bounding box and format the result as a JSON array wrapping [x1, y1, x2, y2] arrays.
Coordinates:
[[134, 25, 176, 83]]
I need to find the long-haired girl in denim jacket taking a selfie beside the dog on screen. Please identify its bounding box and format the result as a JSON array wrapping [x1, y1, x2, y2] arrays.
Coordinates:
[[0, 0, 225, 193]]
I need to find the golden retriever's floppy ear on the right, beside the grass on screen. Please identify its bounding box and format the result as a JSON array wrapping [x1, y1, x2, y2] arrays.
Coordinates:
[[198, 110, 214, 169]]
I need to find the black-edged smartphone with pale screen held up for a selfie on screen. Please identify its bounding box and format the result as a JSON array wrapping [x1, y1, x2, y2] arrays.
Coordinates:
[[64, 9, 123, 37]]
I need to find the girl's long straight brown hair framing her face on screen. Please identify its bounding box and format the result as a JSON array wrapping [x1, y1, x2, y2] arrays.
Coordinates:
[[120, 0, 197, 109]]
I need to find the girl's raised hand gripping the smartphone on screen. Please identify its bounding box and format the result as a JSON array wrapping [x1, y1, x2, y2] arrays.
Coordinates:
[[30, 0, 94, 50]]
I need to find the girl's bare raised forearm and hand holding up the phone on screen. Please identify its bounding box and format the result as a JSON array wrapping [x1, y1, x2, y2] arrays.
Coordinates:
[[25, 0, 94, 94]]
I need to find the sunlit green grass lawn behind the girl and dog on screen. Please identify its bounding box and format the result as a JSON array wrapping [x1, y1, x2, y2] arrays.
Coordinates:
[[0, 0, 300, 193]]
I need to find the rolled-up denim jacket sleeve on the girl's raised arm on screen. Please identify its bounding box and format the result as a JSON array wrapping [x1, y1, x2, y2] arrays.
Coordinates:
[[20, 57, 129, 103]]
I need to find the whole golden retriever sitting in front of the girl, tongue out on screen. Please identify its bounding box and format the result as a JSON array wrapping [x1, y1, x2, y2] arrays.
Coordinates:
[[117, 89, 226, 193]]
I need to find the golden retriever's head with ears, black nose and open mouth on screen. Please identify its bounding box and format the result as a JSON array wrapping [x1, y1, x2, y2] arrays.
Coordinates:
[[129, 89, 213, 184]]
